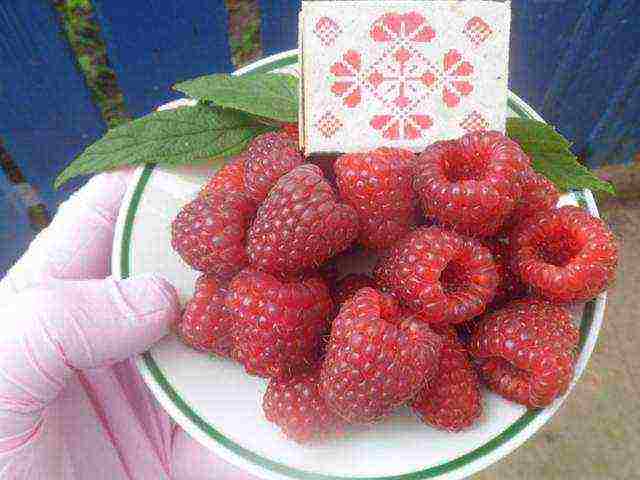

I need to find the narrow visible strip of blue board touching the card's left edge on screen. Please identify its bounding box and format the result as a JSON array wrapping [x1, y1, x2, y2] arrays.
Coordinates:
[[260, 0, 302, 55]]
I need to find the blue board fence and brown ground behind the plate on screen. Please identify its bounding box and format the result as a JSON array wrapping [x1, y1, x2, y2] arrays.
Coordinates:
[[0, 0, 640, 480]]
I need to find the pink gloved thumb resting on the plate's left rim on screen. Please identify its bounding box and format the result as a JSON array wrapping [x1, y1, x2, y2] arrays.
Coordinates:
[[0, 276, 179, 446]]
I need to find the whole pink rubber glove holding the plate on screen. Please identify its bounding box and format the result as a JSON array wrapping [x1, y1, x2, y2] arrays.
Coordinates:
[[0, 171, 260, 480]]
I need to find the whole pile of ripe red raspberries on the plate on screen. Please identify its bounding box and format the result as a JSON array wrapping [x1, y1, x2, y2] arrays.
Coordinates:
[[172, 126, 618, 442]]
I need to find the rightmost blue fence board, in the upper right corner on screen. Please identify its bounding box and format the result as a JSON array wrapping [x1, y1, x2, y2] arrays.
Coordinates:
[[541, 0, 640, 166]]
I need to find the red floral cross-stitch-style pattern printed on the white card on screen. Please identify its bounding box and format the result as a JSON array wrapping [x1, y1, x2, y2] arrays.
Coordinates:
[[328, 12, 492, 140]]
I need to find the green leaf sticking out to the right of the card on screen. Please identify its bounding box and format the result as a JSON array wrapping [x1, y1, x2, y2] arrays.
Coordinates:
[[507, 118, 615, 195]]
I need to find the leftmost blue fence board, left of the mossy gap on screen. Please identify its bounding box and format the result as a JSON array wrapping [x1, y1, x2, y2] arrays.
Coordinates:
[[0, 0, 105, 212]]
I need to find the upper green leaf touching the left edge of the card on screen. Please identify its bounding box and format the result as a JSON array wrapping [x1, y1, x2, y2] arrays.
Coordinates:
[[173, 73, 298, 122]]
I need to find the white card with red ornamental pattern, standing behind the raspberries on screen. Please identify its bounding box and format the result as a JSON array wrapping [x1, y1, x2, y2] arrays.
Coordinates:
[[299, 0, 511, 154]]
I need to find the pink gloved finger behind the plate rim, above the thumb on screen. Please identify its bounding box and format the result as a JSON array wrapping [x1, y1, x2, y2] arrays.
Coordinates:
[[0, 168, 133, 293]]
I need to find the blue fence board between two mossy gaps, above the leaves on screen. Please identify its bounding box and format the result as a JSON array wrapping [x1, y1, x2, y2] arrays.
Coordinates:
[[94, 0, 233, 117]]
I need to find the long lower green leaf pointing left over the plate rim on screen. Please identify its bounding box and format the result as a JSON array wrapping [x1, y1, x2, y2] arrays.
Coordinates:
[[54, 104, 273, 188]]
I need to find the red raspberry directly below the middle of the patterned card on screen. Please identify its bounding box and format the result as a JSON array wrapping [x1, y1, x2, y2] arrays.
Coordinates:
[[334, 148, 416, 248]]
